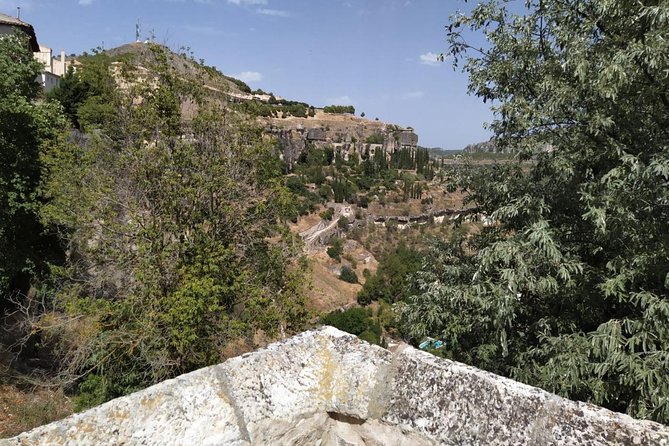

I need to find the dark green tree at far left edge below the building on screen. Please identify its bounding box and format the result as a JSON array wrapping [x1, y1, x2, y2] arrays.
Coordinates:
[[0, 35, 65, 308]]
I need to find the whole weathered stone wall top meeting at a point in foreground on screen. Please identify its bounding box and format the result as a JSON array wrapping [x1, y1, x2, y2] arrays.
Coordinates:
[[0, 327, 669, 446]]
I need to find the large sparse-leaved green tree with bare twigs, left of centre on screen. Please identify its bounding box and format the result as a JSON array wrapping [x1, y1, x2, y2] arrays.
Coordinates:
[[33, 46, 307, 406]]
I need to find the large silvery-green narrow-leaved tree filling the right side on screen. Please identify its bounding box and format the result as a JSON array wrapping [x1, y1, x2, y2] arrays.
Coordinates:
[[398, 0, 669, 423]]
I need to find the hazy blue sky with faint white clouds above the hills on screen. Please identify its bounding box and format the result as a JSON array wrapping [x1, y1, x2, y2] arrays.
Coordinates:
[[0, 0, 492, 149]]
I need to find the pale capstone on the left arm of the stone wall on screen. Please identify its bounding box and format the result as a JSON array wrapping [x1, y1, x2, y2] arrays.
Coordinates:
[[0, 366, 248, 446]]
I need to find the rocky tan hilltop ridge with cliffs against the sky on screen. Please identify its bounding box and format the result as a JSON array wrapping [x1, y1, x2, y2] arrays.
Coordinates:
[[95, 43, 418, 164]]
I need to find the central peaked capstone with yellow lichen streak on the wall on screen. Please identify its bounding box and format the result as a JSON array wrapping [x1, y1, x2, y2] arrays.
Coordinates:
[[220, 329, 392, 444]]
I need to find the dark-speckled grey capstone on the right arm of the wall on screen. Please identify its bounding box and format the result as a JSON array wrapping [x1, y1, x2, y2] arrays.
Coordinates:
[[383, 349, 669, 445]]
